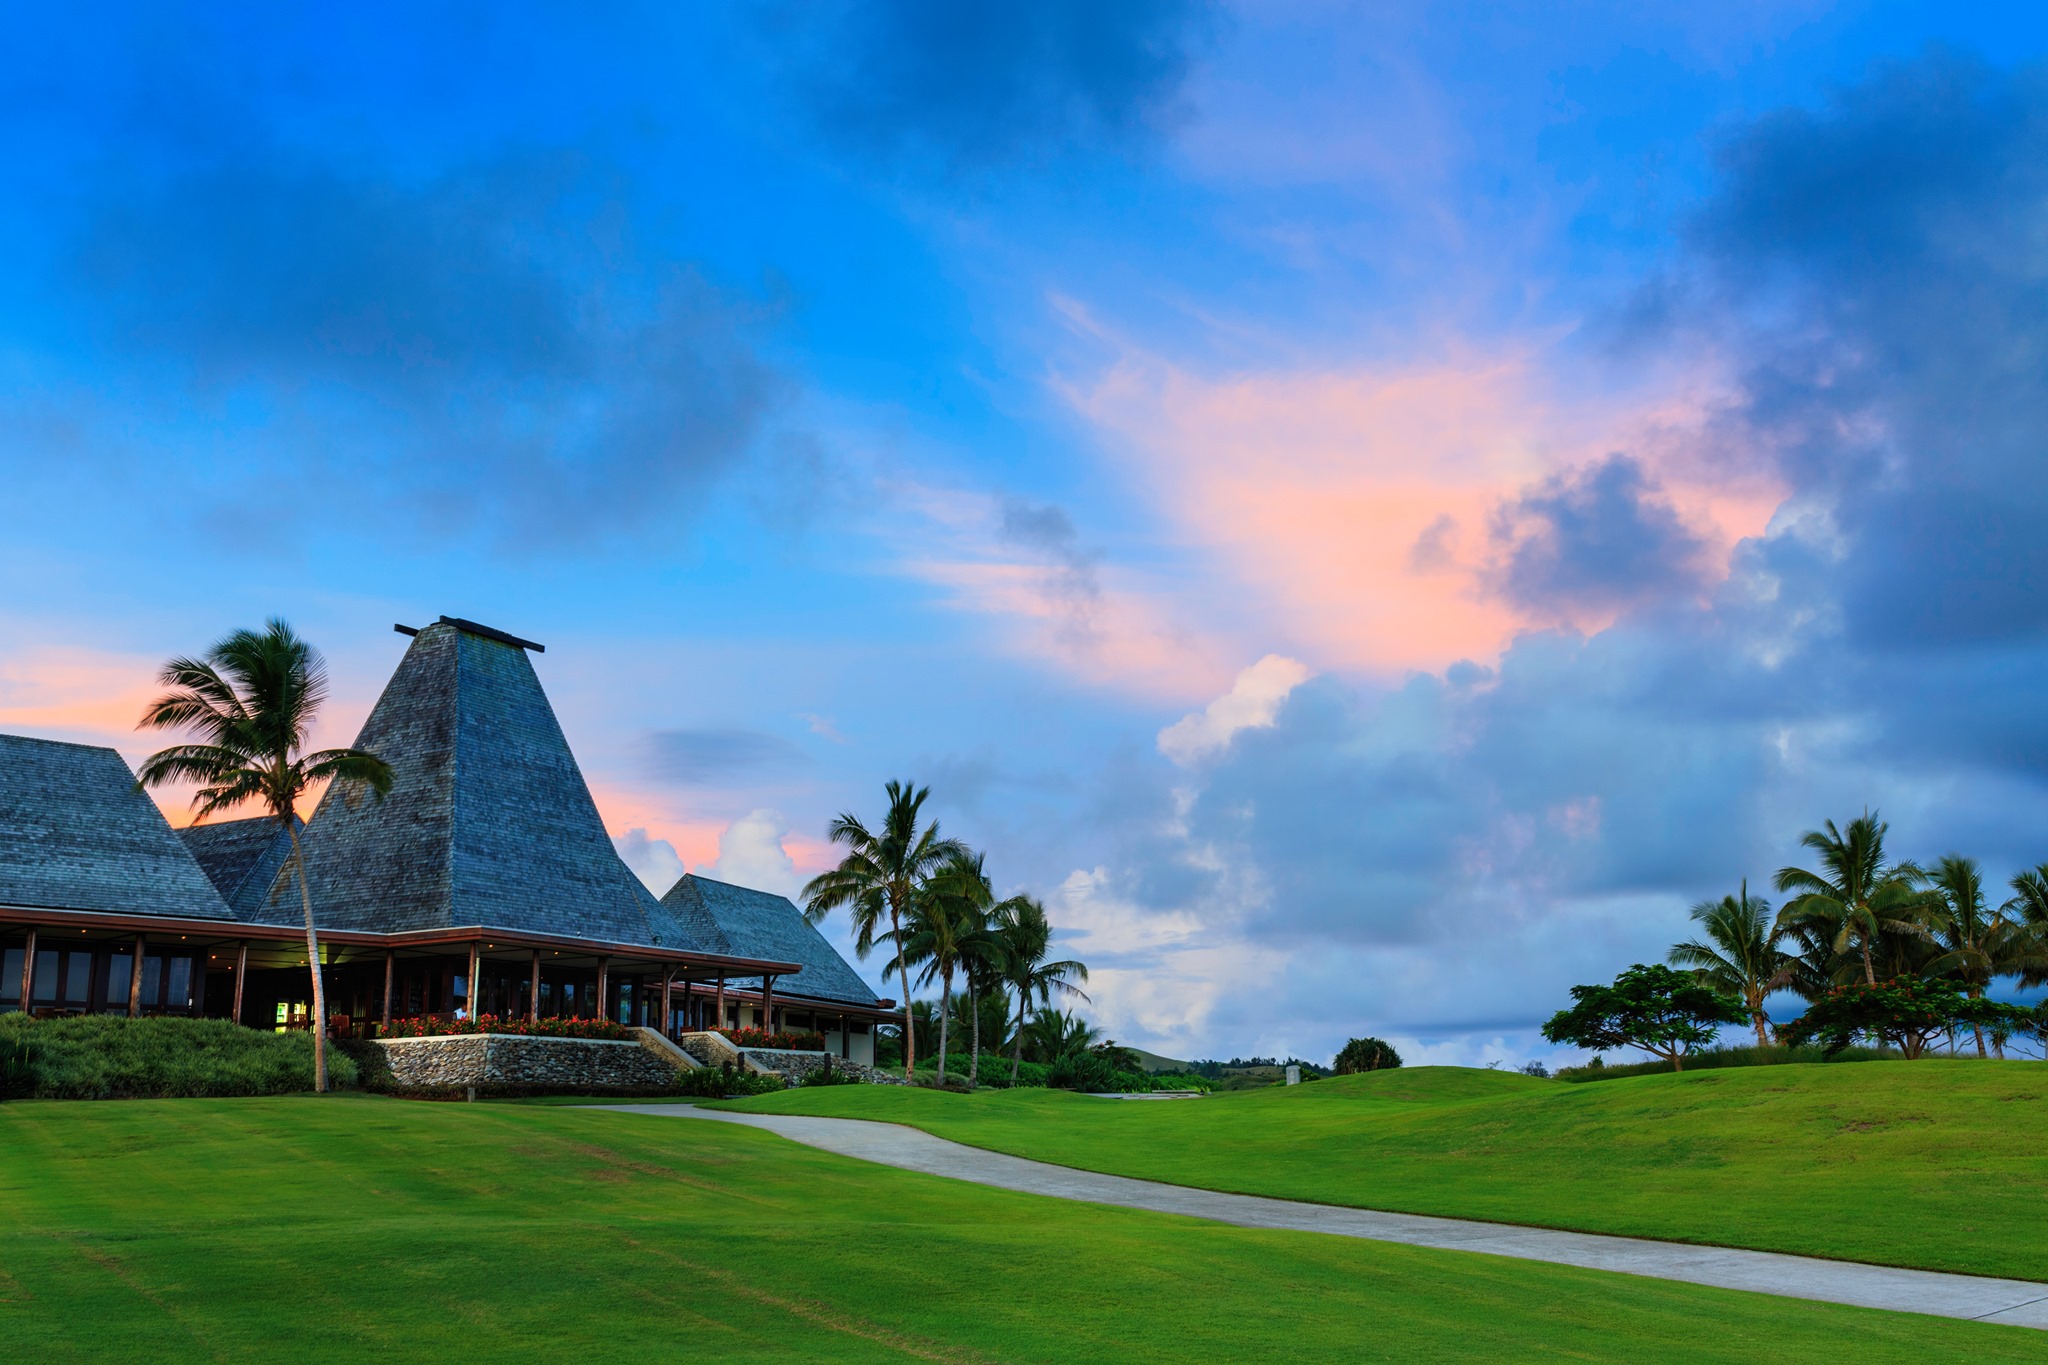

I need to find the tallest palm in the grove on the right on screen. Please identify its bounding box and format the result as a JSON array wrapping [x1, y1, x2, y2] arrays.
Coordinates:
[[1778, 812, 1939, 986]]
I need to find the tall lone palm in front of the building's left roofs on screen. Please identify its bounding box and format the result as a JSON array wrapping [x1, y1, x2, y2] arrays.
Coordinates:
[[137, 618, 391, 1091]]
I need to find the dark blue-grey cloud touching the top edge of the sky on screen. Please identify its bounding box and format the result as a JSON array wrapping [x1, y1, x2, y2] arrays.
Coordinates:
[[774, 0, 1210, 172]]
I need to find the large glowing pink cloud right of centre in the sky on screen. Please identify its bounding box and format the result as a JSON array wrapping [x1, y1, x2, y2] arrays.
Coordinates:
[[1063, 327, 1780, 671]]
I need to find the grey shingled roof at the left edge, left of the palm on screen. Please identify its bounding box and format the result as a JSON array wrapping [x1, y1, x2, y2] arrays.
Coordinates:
[[0, 735, 233, 919]]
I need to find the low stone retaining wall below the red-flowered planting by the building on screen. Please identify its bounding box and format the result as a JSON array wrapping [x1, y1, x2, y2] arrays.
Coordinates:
[[377, 1033, 678, 1091]]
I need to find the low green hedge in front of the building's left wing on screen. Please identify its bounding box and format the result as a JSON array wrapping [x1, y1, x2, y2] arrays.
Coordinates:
[[0, 1015, 356, 1099]]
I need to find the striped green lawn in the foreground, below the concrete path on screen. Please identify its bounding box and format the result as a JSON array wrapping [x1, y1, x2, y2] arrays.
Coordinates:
[[0, 1097, 2044, 1365]]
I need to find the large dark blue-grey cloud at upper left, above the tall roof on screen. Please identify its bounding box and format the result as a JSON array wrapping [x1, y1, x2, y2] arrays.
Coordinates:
[[32, 139, 782, 546]]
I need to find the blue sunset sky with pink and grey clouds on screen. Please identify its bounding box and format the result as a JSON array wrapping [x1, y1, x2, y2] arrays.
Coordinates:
[[0, 0, 2048, 1064]]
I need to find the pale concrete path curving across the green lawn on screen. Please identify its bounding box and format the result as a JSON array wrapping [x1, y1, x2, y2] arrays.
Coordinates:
[[592, 1105, 2048, 1328]]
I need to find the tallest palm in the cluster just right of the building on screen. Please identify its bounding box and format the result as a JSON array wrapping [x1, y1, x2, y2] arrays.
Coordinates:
[[803, 782, 967, 1081]]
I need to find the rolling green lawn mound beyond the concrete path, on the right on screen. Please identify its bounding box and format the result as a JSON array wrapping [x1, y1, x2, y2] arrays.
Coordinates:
[[727, 1060, 2048, 1279]]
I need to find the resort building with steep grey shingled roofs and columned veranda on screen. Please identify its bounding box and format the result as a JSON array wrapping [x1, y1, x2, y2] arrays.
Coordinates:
[[0, 616, 893, 1062]]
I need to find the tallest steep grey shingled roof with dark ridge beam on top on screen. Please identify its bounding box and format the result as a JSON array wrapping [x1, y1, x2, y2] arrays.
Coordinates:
[[303, 618, 700, 950]]
